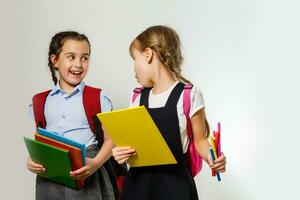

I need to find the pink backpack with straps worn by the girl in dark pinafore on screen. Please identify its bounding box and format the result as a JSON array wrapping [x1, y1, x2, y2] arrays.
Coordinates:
[[131, 84, 202, 176]]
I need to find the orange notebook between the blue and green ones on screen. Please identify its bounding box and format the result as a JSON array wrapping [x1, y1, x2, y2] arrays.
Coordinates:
[[34, 134, 84, 189]]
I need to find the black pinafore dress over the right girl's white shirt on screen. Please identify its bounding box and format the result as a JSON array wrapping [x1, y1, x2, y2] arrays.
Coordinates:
[[120, 83, 198, 200]]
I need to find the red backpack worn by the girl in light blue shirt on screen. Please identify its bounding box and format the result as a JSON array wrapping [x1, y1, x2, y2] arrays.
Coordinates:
[[32, 85, 127, 197]]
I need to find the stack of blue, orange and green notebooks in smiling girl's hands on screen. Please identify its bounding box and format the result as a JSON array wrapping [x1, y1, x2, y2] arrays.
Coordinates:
[[24, 128, 86, 189]]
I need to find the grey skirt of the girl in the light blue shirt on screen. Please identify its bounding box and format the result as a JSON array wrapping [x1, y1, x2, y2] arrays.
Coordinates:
[[36, 146, 115, 200]]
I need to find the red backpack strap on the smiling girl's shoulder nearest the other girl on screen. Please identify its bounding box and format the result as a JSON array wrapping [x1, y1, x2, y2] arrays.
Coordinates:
[[82, 85, 101, 134]]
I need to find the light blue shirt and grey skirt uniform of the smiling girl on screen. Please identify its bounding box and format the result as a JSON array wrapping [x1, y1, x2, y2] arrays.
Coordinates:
[[29, 82, 115, 200]]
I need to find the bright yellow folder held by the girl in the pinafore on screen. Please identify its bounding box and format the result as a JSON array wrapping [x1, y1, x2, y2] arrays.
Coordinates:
[[97, 106, 177, 167]]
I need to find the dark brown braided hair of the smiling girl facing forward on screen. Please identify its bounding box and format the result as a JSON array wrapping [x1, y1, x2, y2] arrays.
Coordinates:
[[48, 31, 91, 84]]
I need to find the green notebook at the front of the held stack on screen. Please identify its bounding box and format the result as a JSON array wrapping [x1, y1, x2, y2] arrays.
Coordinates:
[[24, 137, 77, 189]]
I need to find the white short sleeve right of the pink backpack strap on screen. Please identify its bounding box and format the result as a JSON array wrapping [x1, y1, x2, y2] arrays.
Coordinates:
[[190, 86, 205, 118]]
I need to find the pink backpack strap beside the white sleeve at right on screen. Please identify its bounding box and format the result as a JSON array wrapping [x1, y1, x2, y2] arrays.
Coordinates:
[[183, 84, 193, 139]]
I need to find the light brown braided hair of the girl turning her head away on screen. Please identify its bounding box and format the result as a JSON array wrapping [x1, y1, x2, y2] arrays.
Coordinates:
[[129, 25, 210, 137]]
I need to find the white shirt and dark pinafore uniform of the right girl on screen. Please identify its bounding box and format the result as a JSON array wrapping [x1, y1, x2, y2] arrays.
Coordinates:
[[120, 82, 204, 200]]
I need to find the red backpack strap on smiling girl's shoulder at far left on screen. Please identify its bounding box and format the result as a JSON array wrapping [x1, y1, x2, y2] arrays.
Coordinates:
[[32, 90, 51, 128]]
